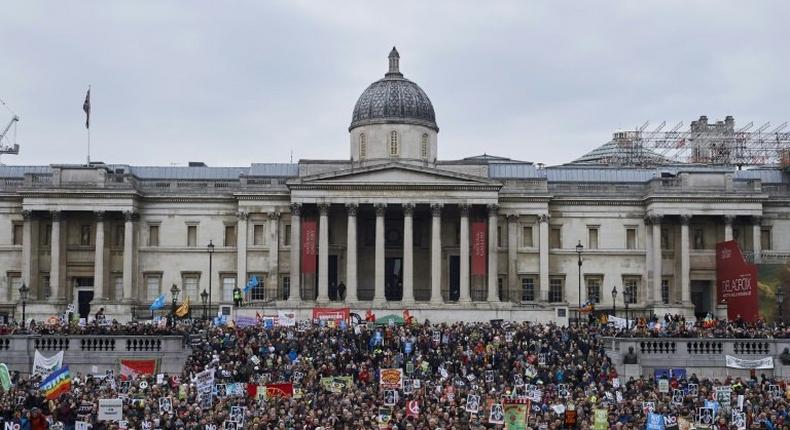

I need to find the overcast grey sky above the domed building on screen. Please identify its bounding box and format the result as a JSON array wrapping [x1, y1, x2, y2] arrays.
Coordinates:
[[0, 0, 790, 166]]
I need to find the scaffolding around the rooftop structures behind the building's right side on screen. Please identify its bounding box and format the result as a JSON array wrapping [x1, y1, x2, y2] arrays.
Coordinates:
[[596, 116, 790, 169]]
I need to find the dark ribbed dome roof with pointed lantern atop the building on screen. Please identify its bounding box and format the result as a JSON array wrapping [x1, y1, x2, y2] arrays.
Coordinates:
[[348, 47, 439, 131]]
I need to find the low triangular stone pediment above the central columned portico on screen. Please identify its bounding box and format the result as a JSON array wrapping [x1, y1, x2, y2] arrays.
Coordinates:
[[295, 163, 498, 186]]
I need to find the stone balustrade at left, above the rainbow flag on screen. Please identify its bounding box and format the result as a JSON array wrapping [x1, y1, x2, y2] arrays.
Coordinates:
[[0, 335, 191, 374]]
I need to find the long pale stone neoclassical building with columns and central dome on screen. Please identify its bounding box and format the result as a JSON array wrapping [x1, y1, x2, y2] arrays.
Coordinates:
[[0, 49, 790, 322]]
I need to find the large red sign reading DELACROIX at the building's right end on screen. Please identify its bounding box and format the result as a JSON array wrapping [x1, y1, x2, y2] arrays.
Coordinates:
[[716, 240, 759, 321]]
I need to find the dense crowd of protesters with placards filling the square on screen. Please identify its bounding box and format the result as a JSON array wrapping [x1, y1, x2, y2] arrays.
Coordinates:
[[0, 316, 790, 430]]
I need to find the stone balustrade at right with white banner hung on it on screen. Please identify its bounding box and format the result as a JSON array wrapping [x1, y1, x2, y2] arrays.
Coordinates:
[[604, 337, 790, 377]]
